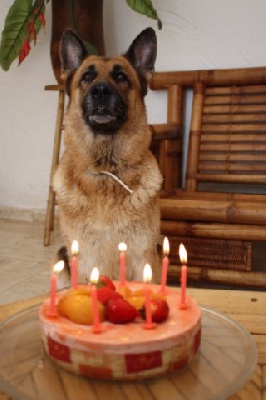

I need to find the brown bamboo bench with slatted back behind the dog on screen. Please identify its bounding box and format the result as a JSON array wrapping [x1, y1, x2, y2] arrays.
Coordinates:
[[150, 68, 266, 287]]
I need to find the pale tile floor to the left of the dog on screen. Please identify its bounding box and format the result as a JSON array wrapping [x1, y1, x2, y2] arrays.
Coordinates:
[[0, 220, 62, 305]]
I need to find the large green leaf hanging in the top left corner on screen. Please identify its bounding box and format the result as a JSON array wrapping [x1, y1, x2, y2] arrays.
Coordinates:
[[0, 0, 45, 71]]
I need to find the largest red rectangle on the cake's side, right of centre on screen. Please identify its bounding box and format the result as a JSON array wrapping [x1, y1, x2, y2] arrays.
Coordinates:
[[125, 351, 162, 374]]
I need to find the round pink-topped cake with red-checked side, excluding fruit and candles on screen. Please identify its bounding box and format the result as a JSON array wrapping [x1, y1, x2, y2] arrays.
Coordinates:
[[39, 282, 201, 380]]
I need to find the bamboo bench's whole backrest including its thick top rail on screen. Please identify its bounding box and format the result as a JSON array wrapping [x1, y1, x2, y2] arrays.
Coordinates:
[[151, 68, 266, 194]]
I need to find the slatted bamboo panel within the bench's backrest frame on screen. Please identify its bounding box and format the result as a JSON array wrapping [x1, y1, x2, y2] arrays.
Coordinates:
[[186, 82, 266, 191]]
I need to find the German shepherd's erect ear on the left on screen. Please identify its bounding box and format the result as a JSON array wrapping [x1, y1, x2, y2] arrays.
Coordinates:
[[59, 29, 88, 76]]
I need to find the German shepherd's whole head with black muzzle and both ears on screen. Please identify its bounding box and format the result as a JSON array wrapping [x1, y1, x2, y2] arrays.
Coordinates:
[[60, 28, 157, 135]]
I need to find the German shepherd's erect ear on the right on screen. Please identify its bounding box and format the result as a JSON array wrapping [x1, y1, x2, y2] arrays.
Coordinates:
[[124, 28, 157, 94]]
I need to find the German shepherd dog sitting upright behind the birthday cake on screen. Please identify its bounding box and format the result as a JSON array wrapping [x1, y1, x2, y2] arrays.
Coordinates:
[[54, 28, 162, 282]]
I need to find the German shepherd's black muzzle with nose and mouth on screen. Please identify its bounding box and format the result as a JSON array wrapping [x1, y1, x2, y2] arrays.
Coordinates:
[[83, 82, 127, 133]]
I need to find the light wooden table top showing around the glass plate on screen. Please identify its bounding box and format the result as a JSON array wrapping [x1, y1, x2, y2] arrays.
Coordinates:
[[0, 289, 266, 400]]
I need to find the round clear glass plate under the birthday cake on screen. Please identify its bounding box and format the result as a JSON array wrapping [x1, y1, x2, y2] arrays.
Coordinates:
[[0, 305, 257, 400]]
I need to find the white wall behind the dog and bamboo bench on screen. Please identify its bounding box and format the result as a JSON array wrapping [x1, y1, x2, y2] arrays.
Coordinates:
[[0, 0, 266, 216]]
